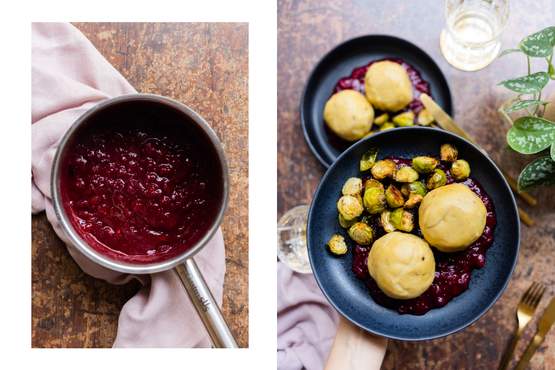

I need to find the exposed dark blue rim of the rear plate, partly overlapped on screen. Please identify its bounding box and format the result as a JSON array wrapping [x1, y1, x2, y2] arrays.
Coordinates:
[[301, 35, 453, 167]]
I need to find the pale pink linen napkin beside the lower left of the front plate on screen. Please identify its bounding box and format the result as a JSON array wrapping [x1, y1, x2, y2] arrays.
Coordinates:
[[277, 262, 386, 370]]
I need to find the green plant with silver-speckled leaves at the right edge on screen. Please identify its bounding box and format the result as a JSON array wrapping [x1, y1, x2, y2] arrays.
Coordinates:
[[499, 26, 555, 190]]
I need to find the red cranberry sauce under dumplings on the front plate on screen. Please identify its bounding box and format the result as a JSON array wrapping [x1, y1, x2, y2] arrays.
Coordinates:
[[352, 158, 496, 315]]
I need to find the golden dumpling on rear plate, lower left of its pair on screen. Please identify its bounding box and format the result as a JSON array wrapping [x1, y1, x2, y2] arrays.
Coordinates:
[[324, 90, 374, 141]]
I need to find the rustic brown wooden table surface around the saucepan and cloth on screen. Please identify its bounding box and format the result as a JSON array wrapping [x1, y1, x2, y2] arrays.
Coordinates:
[[32, 23, 248, 347]]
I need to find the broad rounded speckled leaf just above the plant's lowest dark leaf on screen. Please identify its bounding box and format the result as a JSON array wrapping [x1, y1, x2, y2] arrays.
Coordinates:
[[507, 116, 555, 154]]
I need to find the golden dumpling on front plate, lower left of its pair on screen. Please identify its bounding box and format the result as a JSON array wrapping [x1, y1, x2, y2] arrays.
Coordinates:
[[368, 231, 436, 299]]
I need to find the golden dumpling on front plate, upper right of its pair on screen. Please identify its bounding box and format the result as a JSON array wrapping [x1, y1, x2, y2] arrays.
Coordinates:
[[418, 184, 487, 252]]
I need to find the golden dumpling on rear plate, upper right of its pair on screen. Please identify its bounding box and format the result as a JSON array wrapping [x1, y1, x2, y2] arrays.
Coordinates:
[[364, 60, 412, 112]]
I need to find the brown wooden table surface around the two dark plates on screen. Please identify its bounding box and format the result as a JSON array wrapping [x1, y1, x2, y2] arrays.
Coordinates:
[[278, 0, 555, 370]]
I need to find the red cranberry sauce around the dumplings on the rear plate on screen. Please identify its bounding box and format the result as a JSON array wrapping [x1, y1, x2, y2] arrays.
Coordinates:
[[333, 58, 431, 114]]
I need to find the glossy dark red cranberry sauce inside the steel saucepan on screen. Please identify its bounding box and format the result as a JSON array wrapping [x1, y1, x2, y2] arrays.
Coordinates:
[[61, 117, 222, 263]]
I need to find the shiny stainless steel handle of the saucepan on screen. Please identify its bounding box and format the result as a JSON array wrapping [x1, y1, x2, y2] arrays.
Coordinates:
[[175, 258, 237, 348]]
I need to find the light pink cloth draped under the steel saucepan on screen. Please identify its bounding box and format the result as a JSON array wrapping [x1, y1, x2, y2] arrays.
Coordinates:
[[31, 23, 225, 347]]
